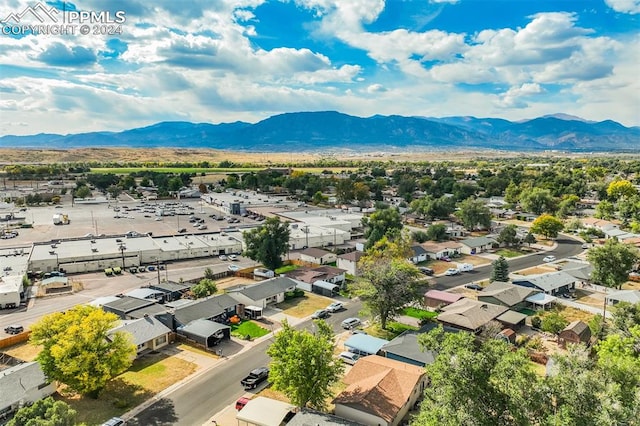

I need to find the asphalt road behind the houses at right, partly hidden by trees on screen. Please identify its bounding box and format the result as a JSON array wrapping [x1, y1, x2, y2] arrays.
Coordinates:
[[431, 235, 584, 290]]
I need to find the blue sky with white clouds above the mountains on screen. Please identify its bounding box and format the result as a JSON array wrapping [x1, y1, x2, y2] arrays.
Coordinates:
[[0, 0, 640, 135]]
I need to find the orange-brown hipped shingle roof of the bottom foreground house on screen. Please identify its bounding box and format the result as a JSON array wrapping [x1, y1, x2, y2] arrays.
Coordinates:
[[333, 355, 425, 422]]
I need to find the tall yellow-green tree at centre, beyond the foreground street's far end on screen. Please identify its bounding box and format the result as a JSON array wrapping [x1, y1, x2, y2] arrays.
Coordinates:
[[352, 238, 421, 329]]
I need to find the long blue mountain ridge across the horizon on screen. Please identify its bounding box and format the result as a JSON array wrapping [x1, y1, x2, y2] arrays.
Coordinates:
[[0, 111, 640, 152]]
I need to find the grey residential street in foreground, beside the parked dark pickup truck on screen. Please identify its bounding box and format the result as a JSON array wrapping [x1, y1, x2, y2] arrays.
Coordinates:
[[127, 301, 362, 426]]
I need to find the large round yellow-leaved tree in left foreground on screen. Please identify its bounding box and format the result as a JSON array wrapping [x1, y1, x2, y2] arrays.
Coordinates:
[[30, 305, 136, 397]]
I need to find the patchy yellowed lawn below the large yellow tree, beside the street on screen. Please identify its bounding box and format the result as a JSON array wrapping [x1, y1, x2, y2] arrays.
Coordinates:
[[63, 354, 197, 425]]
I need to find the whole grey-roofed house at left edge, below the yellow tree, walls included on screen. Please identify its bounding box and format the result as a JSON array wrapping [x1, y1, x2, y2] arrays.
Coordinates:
[[0, 355, 56, 419]]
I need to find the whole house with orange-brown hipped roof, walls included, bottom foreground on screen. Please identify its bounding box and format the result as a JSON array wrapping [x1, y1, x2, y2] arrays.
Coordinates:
[[333, 355, 427, 426]]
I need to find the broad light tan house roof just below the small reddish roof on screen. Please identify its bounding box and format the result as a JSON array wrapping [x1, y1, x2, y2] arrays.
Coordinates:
[[438, 298, 508, 331]]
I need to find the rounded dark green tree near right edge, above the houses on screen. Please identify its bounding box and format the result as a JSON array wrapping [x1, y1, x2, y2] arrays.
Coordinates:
[[587, 238, 639, 288]]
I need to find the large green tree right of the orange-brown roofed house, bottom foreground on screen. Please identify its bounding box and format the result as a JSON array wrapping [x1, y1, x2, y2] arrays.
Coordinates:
[[412, 327, 547, 426]]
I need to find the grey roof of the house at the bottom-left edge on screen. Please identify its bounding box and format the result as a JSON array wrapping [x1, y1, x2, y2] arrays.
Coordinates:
[[0, 361, 55, 411]]
